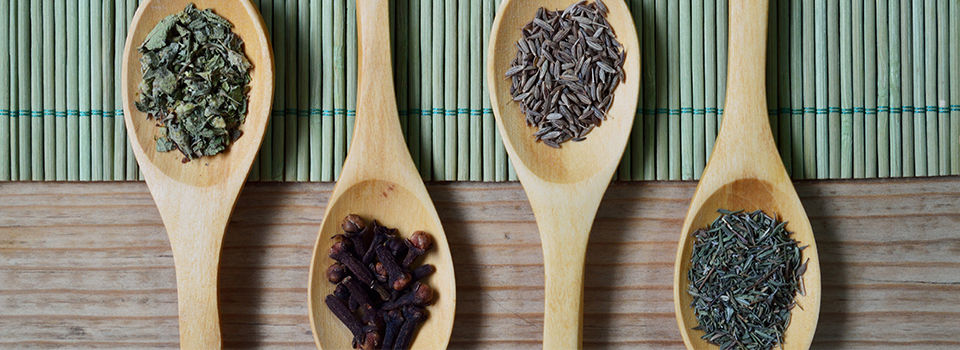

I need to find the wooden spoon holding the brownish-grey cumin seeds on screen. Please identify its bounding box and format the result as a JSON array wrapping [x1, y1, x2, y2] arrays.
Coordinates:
[[487, 0, 640, 349]]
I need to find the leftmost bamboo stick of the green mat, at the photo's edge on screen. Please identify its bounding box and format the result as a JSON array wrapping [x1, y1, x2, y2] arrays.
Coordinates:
[[0, 0, 13, 181]]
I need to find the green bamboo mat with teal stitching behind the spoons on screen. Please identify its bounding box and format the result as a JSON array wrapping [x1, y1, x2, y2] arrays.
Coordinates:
[[0, 0, 960, 181]]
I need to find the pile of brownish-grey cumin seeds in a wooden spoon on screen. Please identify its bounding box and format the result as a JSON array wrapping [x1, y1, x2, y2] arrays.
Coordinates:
[[506, 0, 625, 148]]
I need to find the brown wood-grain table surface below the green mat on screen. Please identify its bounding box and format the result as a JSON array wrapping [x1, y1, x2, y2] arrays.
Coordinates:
[[0, 177, 960, 349]]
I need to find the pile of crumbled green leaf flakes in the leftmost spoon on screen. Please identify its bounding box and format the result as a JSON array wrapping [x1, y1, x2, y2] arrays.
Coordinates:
[[136, 4, 251, 162]]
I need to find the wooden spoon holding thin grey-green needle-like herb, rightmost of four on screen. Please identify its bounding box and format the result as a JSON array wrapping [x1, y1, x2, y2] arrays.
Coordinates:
[[673, 0, 820, 349]]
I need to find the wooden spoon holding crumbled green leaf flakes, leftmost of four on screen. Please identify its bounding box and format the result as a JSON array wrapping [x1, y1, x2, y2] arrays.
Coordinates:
[[122, 0, 273, 349]]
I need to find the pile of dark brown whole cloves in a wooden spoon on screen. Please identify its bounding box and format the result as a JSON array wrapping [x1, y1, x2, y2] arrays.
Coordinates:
[[326, 215, 436, 349]]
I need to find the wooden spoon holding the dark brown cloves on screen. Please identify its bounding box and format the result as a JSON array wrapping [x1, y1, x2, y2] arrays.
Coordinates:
[[308, 0, 457, 349]]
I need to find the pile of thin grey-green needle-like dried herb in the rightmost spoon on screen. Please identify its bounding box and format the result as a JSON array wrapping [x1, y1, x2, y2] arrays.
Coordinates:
[[687, 210, 807, 349]]
